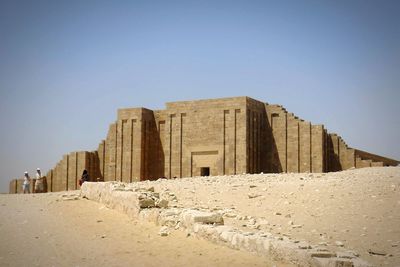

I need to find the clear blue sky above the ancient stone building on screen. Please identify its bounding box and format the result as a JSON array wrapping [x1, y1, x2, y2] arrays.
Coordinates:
[[0, 0, 400, 192]]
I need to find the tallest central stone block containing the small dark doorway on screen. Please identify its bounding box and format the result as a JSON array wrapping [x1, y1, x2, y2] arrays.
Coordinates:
[[162, 97, 247, 178]]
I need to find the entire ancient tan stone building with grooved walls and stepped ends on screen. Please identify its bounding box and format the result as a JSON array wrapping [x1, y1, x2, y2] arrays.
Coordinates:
[[10, 97, 399, 192]]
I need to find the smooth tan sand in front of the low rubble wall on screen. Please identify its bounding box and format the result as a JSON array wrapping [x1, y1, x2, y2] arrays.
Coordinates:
[[0, 192, 280, 266]]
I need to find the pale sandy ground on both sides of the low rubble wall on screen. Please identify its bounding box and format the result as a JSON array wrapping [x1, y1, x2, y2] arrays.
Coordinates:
[[0, 167, 400, 266]]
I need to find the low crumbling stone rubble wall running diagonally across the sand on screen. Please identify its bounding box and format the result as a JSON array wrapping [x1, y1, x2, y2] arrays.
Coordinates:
[[81, 182, 371, 267]]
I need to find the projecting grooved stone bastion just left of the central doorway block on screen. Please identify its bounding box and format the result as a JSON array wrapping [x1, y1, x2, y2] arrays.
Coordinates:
[[97, 108, 156, 182]]
